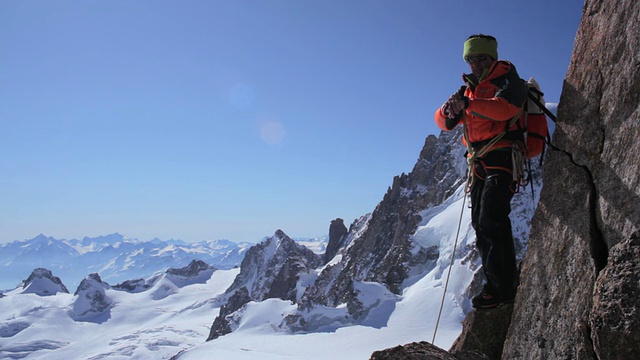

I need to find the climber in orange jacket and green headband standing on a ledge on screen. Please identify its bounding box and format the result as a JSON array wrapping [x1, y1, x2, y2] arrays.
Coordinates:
[[435, 34, 527, 309]]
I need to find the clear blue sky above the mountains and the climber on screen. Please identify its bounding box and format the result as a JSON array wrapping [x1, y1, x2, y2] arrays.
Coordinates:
[[0, 0, 583, 242]]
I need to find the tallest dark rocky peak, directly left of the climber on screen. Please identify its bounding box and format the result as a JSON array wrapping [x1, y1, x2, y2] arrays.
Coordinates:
[[290, 127, 465, 326]]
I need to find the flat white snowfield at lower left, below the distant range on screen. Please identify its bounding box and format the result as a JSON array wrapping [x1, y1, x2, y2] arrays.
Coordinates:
[[0, 269, 238, 359]]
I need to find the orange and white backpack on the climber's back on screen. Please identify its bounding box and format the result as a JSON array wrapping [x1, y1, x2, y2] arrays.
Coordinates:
[[519, 78, 555, 161]]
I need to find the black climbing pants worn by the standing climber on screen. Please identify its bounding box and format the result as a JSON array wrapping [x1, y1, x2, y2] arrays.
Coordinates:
[[470, 149, 517, 298]]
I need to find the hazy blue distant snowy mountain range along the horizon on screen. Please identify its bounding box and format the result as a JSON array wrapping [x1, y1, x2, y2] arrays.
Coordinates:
[[0, 233, 327, 289]]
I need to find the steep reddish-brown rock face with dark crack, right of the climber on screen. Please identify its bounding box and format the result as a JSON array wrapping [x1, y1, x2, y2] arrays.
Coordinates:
[[503, 0, 640, 359]]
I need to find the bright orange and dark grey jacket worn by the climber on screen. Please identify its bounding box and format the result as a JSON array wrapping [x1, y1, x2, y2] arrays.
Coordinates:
[[435, 60, 528, 150]]
